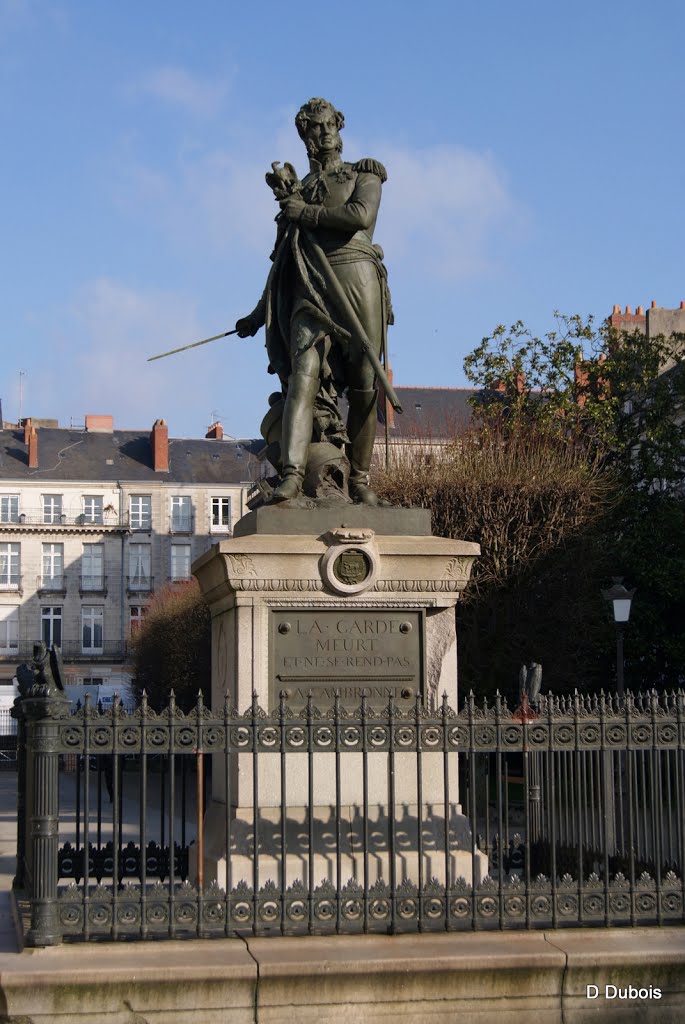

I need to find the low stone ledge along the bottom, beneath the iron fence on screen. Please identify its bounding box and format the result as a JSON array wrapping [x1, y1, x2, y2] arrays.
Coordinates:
[[0, 928, 685, 1024]]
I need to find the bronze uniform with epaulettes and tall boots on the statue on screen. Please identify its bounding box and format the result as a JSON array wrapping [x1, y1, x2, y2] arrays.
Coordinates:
[[245, 153, 390, 500]]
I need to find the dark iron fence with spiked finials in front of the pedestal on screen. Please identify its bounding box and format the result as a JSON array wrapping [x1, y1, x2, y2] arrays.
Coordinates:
[[9, 691, 685, 945]]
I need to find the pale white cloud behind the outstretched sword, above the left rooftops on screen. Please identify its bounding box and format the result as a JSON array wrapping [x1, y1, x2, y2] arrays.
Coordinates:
[[19, 278, 272, 437]]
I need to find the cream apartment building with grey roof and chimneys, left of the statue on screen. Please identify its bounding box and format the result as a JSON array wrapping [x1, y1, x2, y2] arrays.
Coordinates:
[[0, 416, 263, 686]]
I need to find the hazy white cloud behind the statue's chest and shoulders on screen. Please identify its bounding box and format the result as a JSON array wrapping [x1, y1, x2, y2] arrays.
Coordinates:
[[112, 112, 520, 280]]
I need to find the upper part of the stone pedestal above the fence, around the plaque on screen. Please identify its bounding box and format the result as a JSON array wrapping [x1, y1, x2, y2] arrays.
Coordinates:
[[192, 506, 479, 724]]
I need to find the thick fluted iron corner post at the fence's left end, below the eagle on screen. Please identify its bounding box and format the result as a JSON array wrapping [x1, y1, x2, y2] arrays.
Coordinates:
[[23, 685, 69, 946]]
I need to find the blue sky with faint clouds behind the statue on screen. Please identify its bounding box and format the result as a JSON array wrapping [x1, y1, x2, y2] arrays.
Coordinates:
[[0, 0, 685, 437]]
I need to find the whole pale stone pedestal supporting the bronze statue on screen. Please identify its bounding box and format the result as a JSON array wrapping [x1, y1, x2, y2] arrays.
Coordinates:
[[192, 505, 485, 885]]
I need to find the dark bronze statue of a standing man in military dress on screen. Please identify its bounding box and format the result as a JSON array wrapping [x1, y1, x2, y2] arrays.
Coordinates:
[[236, 98, 391, 505]]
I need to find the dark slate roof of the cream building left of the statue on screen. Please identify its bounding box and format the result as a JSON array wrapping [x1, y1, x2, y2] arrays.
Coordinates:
[[0, 427, 264, 484]]
